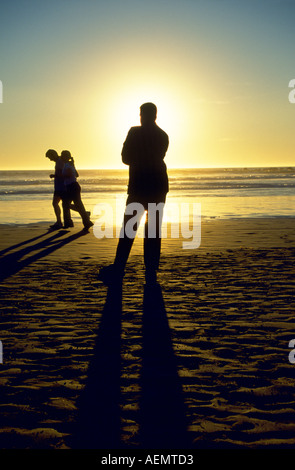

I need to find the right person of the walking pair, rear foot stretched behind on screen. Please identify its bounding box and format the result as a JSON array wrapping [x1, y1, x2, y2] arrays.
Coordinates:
[[61, 150, 93, 230]]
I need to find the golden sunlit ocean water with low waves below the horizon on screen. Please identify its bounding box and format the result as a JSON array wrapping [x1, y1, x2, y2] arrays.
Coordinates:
[[0, 167, 295, 224]]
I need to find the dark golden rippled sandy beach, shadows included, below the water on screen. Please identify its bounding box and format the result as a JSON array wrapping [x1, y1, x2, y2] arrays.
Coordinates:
[[0, 218, 295, 449]]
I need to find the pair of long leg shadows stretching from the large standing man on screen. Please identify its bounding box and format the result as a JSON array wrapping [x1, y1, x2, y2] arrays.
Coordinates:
[[69, 285, 191, 449]]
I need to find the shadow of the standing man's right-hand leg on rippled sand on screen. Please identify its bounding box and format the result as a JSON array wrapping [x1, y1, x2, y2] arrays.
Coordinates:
[[140, 285, 191, 449]]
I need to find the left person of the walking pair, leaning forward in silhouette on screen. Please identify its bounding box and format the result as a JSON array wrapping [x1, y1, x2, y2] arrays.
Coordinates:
[[45, 149, 73, 229]]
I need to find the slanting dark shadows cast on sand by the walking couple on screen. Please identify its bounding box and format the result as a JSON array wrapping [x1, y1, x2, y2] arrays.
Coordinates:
[[0, 230, 88, 282]]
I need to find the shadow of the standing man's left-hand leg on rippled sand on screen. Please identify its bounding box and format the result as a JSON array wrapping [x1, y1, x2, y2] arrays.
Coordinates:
[[70, 284, 122, 449]]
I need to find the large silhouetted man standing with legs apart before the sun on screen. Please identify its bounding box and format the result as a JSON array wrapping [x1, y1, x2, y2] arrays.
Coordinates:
[[99, 103, 169, 284]]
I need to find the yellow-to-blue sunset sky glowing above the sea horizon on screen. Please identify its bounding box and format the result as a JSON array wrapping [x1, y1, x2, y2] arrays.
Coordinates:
[[0, 0, 295, 169]]
